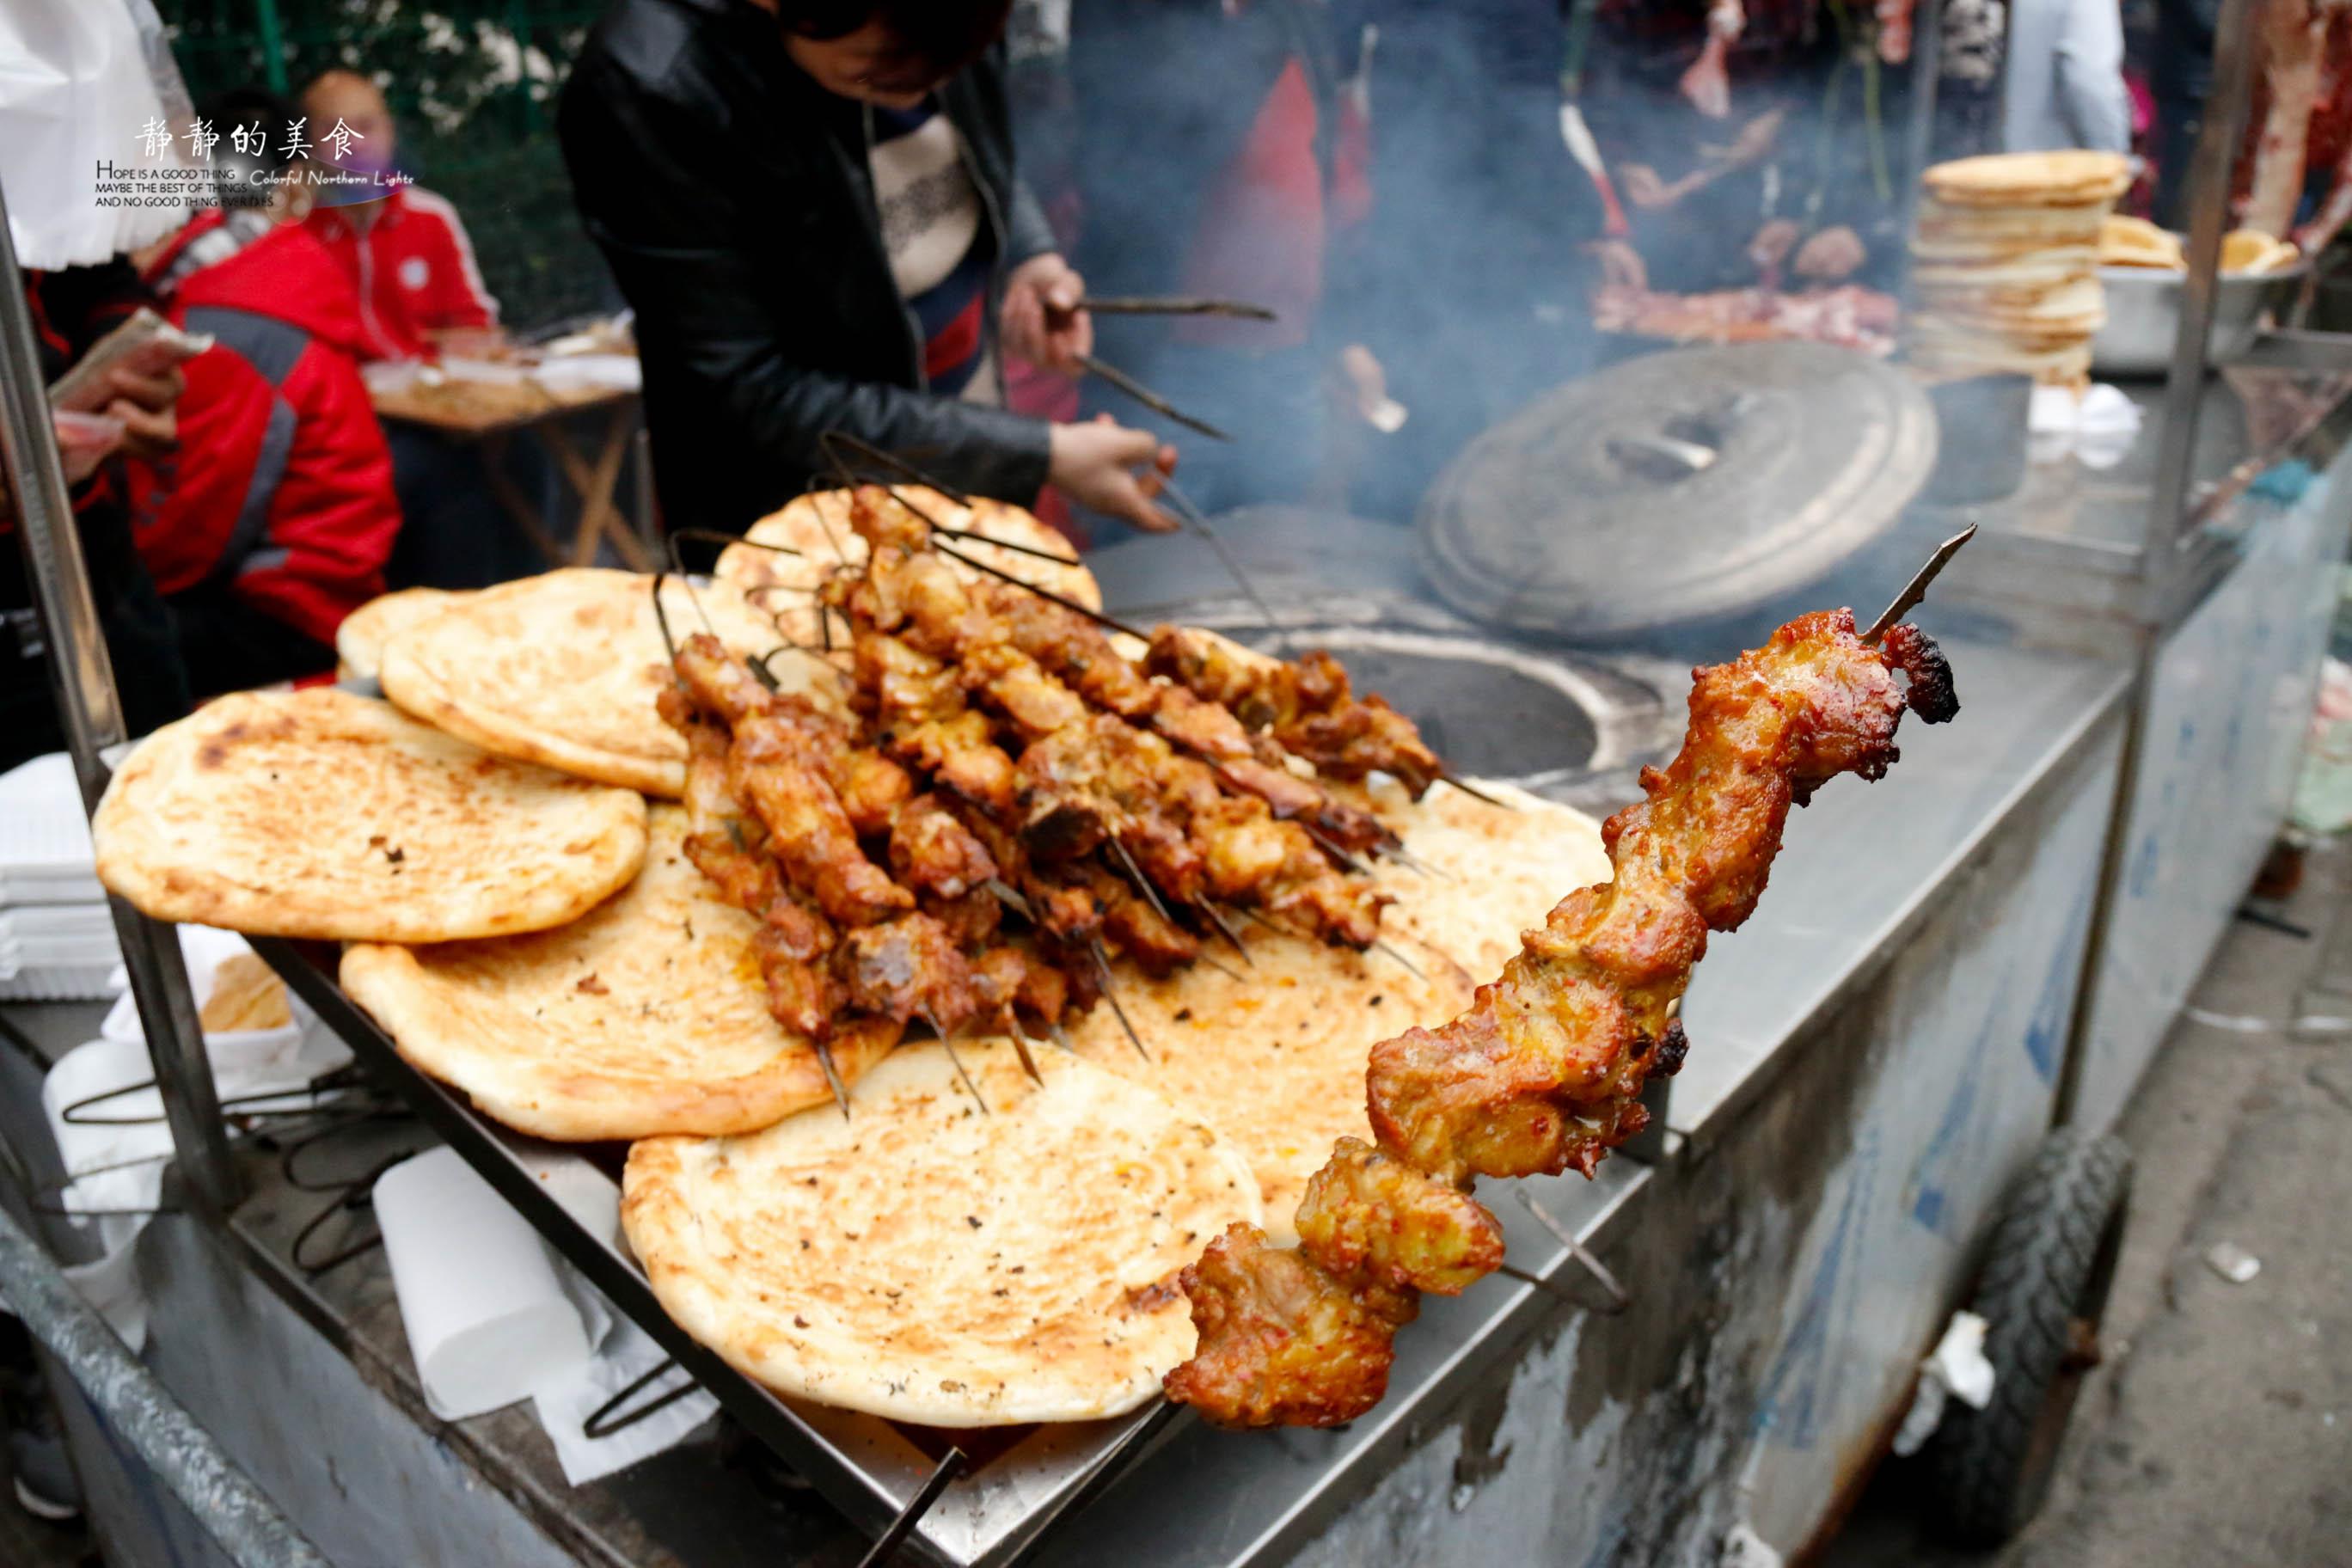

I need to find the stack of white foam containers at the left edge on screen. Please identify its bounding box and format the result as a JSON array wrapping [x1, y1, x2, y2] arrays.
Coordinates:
[[0, 752, 122, 1001]]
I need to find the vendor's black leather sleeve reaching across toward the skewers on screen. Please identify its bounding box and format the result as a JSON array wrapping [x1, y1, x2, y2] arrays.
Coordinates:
[[557, 64, 1051, 503]]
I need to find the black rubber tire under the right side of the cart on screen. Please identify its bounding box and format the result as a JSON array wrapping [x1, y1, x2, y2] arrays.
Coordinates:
[[1920, 1129, 2131, 1547]]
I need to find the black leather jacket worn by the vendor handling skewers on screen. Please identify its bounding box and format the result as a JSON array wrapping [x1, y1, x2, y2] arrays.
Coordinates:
[[557, 0, 1054, 531]]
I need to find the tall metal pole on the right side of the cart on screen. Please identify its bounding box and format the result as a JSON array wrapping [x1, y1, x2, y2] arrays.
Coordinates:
[[2051, 0, 2256, 1126]]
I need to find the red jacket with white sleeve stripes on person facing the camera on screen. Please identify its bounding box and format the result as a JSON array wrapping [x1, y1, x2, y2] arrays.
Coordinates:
[[303, 186, 499, 359]]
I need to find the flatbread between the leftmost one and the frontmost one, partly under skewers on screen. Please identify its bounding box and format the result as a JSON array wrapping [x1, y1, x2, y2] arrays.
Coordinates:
[[343, 806, 889, 1142]]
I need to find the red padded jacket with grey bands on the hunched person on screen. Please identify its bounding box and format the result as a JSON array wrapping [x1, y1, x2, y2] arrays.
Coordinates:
[[132, 211, 400, 642]]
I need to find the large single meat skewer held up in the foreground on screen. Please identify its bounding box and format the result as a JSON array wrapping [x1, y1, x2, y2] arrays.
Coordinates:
[[1167, 583, 1957, 1427]]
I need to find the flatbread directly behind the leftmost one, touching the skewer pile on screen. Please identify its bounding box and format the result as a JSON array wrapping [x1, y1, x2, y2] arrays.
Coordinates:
[[383, 567, 835, 797]]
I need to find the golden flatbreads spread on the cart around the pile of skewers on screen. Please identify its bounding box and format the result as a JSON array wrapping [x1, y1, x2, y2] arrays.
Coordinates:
[[94, 492, 1608, 1427]]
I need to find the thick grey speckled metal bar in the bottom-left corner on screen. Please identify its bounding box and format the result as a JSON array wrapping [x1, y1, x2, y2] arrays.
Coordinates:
[[0, 1206, 332, 1568]]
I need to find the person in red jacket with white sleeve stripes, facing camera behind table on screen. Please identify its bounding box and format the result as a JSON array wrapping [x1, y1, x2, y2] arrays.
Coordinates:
[[301, 70, 499, 359]]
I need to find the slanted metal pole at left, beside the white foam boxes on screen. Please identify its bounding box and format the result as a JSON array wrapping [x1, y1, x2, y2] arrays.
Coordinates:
[[0, 191, 236, 1218]]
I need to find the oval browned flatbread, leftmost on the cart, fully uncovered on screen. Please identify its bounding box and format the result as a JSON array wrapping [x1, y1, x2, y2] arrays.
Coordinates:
[[92, 687, 645, 943]]
